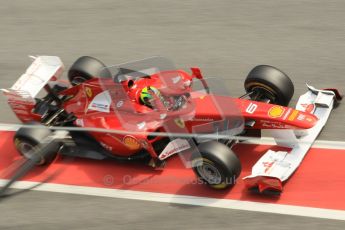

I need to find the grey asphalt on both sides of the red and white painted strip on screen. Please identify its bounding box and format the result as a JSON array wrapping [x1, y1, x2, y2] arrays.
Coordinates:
[[0, 0, 345, 229]]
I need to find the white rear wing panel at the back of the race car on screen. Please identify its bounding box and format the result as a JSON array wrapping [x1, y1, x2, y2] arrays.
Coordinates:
[[2, 56, 64, 98]]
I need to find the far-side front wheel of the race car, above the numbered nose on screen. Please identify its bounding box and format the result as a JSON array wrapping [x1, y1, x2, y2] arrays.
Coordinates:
[[244, 65, 294, 106]]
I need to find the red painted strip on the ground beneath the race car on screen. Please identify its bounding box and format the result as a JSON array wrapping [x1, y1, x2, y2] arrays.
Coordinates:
[[0, 132, 345, 210]]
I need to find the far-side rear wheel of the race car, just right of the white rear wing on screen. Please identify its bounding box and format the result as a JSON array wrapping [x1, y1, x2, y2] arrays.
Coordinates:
[[68, 56, 112, 85]]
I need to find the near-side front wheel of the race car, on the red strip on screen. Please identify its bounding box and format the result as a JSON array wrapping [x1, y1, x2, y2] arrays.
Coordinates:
[[192, 141, 241, 189]]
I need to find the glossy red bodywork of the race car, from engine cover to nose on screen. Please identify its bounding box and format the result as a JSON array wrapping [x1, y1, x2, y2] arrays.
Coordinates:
[[9, 68, 317, 157]]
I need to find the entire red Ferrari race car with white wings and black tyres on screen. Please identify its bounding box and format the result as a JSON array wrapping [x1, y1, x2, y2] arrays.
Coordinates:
[[2, 56, 342, 193]]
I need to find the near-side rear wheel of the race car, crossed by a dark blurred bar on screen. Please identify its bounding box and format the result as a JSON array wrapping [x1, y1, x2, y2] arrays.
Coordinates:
[[14, 126, 60, 165]]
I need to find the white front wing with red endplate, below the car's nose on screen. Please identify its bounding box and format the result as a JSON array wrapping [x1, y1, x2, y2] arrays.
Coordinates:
[[243, 85, 341, 193]]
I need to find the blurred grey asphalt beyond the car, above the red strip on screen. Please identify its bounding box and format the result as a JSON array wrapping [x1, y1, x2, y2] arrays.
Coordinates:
[[0, 0, 345, 140]]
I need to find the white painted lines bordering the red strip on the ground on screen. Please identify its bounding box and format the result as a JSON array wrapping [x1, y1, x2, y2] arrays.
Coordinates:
[[0, 124, 345, 220]]
